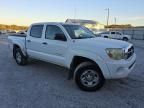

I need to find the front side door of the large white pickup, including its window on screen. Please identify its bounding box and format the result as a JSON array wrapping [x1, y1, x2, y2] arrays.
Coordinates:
[[43, 25, 68, 66]]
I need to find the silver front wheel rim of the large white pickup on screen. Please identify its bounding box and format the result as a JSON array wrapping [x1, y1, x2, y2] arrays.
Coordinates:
[[80, 70, 99, 87]]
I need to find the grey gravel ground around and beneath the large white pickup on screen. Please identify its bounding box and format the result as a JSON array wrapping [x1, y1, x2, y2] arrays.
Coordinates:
[[0, 36, 144, 108]]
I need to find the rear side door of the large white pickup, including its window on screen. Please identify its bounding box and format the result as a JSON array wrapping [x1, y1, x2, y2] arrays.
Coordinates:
[[26, 25, 44, 59]]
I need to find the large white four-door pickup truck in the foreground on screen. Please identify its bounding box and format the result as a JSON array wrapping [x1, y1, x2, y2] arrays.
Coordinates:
[[8, 23, 136, 91]]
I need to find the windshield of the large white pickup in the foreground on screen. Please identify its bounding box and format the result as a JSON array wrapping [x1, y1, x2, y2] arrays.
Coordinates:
[[63, 25, 96, 39]]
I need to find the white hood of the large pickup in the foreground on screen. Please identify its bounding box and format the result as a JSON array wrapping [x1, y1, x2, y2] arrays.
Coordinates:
[[75, 37, 132, 49]]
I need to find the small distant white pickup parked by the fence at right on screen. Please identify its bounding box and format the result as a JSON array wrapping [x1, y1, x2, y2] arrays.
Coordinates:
[[100, 31, 131, 41]]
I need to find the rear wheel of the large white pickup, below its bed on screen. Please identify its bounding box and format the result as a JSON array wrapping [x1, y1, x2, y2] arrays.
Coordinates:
[[13, 48, 27, 66]]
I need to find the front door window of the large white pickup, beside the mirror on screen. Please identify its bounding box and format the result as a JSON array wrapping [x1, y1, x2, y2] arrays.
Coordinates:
[[45, 25, 64, 40]]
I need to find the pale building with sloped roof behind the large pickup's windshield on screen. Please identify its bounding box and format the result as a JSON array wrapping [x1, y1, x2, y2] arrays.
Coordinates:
[[66, 19, 105, 34]]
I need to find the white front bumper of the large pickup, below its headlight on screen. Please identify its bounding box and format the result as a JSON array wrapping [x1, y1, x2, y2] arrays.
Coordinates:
[[107, 53, 136, 79]]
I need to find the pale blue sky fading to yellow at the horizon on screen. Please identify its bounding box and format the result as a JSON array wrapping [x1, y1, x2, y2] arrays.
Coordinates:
[[0, 0, 144, 26]]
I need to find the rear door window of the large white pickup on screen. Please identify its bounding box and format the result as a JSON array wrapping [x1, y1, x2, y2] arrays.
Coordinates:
[[30, 25, 44, 38]]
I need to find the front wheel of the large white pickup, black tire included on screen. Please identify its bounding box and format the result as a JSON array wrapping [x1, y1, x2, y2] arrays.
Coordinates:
[[75, 62, 105, 91]]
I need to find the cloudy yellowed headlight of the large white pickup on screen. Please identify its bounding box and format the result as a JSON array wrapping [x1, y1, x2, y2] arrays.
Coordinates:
[[106, 48, 125, 60]]
